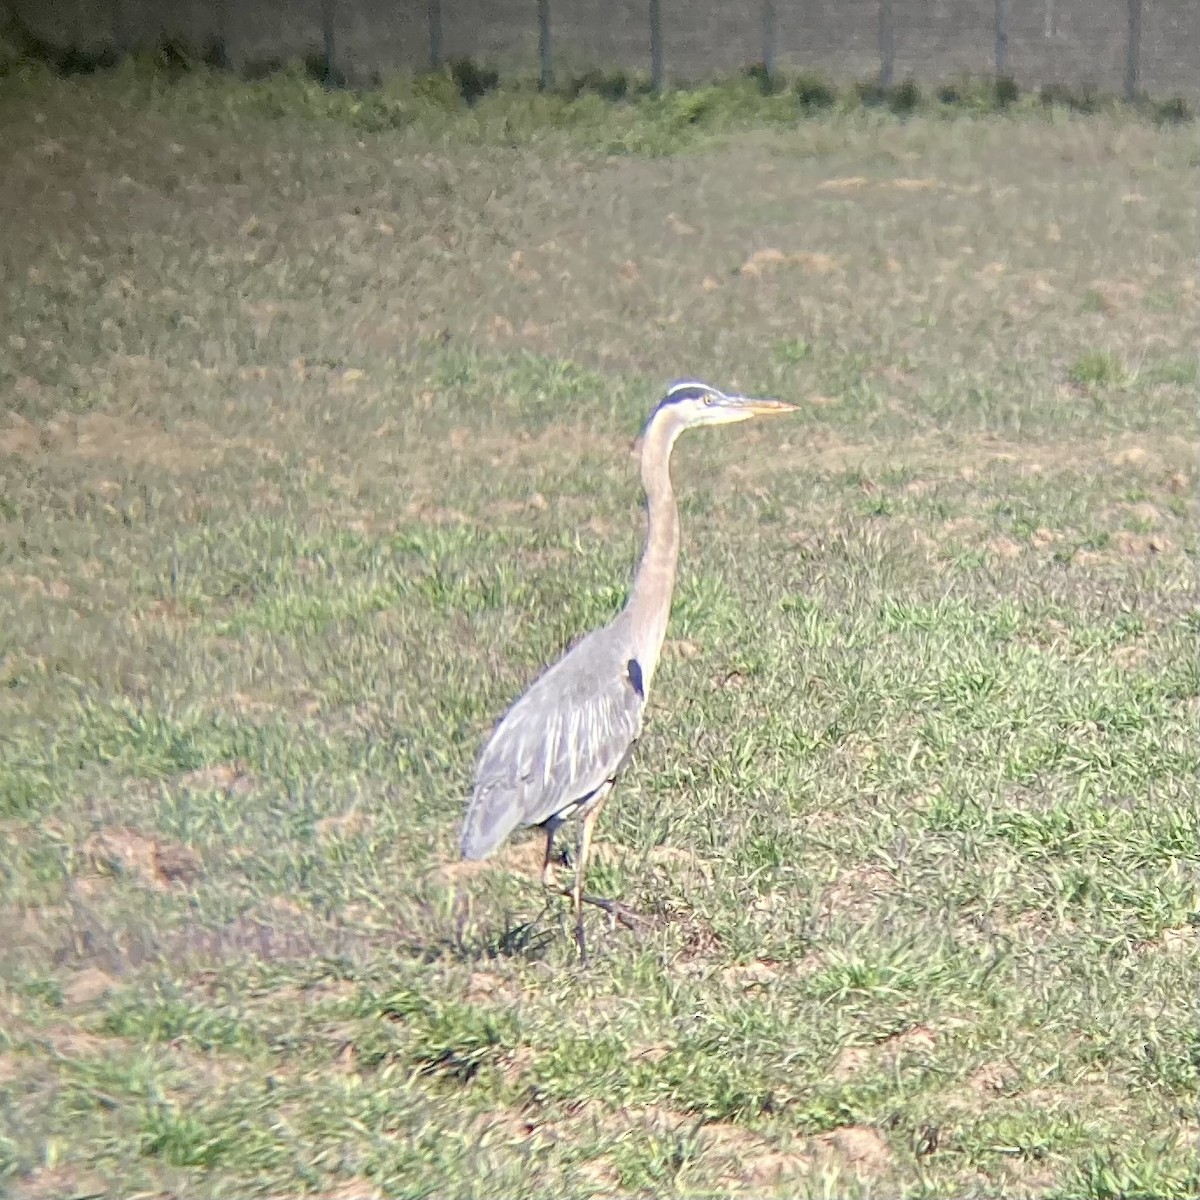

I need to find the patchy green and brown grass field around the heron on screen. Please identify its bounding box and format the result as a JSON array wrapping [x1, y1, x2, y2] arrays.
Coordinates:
[[0, 65, 1200, 1200]]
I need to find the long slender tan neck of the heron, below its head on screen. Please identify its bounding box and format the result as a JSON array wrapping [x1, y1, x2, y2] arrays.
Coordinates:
[[625, 412, 679, 689]]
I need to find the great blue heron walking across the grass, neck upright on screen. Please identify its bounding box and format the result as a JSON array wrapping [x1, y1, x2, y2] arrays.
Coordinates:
[[462, 382, 796, 960]]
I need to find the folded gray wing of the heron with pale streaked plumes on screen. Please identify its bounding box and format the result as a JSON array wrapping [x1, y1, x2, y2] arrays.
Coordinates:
[[462, 625, 646, 858]]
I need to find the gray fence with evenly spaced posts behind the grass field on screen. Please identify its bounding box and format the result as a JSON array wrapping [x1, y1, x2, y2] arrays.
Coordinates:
[[10, 0, 1200, 103]]
